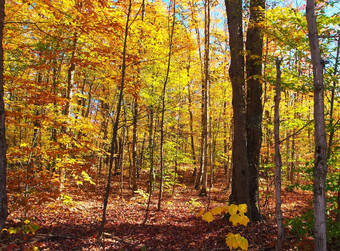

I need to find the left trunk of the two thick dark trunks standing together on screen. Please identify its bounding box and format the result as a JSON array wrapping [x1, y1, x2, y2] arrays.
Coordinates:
[[225, 0, 249, 206]]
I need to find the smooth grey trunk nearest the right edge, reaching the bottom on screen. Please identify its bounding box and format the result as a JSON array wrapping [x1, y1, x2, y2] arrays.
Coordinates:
[[306, 0, 327, 251]]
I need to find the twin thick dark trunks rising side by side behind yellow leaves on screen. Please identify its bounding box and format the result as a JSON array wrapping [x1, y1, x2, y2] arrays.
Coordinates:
[[225, 0, 265, 216]]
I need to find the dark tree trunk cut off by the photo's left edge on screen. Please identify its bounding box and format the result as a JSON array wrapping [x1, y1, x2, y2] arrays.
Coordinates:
[[0, 1, 7, 230]]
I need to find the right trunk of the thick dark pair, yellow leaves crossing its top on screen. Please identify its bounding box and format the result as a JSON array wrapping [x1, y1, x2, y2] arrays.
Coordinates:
[[246, 0, 265, 222]]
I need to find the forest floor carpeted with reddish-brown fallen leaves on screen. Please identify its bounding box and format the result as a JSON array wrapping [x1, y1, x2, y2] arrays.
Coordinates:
[[0, 167, 313, 250]]
